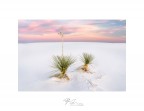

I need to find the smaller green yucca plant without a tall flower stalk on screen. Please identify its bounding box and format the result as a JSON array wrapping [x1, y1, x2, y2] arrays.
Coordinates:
[[81, 53, 94, 72]]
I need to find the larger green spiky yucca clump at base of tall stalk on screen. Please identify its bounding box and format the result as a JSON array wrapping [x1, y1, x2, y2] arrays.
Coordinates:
[[53, 56, 75, 80]]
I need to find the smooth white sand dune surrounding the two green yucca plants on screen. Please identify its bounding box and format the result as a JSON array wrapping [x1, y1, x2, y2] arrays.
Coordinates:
[[18, 42, 126, 91]]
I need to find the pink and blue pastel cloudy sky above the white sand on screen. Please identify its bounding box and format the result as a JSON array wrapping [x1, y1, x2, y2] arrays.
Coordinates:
[[18, 20, 126, 42]]
